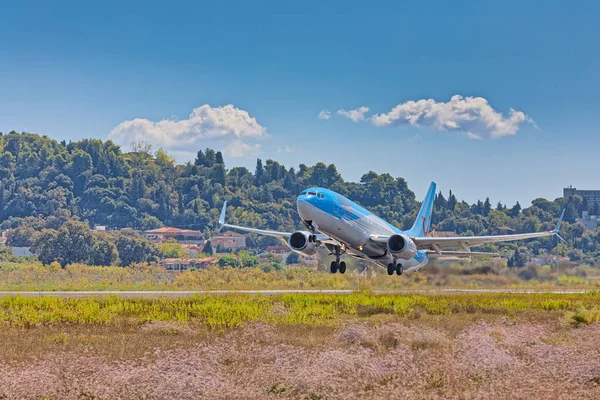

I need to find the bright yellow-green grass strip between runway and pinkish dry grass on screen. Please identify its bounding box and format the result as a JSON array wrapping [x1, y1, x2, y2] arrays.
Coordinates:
[[0, 292, 600, 329]]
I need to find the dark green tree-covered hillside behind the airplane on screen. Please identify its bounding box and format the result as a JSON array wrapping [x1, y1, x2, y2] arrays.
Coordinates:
[[0, 132, 600, 262]]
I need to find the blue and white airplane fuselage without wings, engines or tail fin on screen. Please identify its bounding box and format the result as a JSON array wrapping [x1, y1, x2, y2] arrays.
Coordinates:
[[297, 187, 428, 270]]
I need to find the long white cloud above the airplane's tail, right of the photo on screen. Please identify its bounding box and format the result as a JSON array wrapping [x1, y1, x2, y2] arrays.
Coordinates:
[[371, 95, 535, 139]]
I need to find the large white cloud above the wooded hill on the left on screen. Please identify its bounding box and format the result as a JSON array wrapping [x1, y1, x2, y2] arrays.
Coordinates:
[[108, 104, 268, 157]]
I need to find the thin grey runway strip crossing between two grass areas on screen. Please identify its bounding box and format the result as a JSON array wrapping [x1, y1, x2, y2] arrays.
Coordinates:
[[0, 289, 594, 298]]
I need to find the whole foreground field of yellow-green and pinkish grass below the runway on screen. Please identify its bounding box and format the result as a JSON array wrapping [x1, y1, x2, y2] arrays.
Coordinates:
[[0, 292, 600, 400]]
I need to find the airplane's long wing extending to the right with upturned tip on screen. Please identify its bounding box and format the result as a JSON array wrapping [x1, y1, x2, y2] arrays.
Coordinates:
[[411, 210, 565, 254]]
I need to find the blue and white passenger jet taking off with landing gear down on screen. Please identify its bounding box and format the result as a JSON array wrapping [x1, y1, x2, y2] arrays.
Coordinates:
[[219, 182, 565, 275]]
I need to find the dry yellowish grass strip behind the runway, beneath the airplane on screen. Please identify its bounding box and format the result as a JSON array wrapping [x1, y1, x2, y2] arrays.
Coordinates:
[[0, 260, 600, 291]]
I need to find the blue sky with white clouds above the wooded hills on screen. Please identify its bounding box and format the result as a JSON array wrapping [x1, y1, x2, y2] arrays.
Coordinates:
[[0, 1, 600, 205]]
